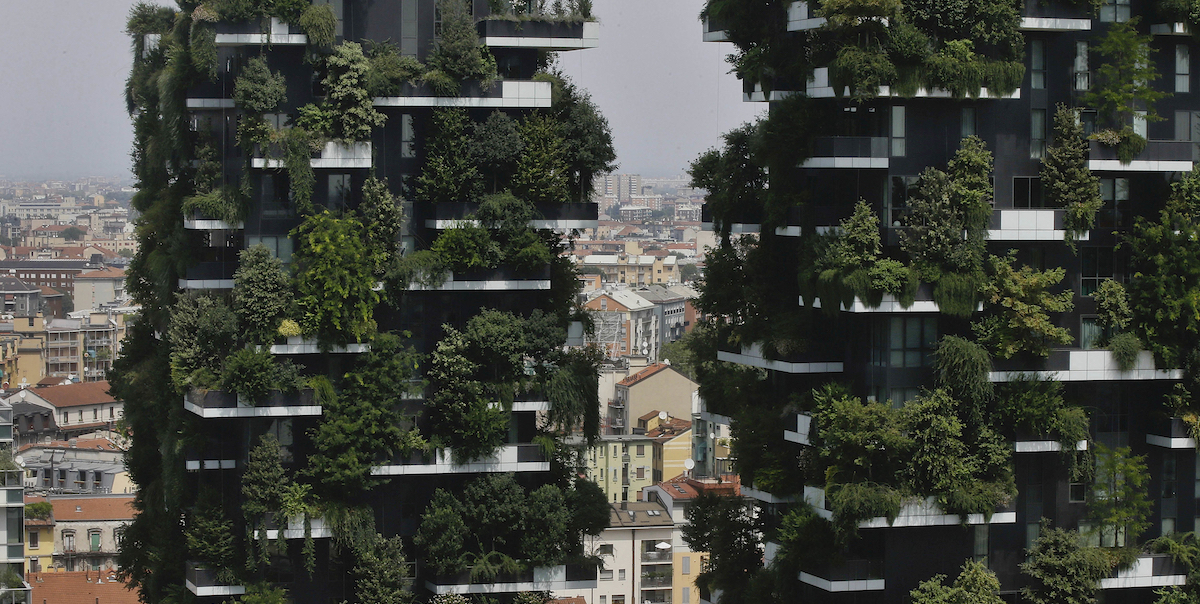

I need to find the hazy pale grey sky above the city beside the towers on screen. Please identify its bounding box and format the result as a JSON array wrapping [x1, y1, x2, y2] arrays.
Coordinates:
[[0, 0, 763, 179]]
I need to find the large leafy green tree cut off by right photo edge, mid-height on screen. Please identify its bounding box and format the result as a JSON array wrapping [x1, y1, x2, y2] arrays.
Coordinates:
[[1126, 169, 1200, 367]]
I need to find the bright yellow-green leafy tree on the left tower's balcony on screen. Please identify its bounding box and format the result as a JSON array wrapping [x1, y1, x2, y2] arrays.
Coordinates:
[[292, 211, 379, 348]]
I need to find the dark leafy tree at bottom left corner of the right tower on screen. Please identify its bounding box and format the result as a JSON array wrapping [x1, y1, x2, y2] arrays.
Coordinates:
[[683, 494, 763, 602]]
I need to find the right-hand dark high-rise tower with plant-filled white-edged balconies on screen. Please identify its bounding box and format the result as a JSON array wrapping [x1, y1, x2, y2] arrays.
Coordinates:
[[697, 0, 1200, 603]]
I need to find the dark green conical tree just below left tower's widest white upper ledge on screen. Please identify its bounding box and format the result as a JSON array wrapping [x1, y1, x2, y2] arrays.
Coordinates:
[[416, 107, 482, 203]]
